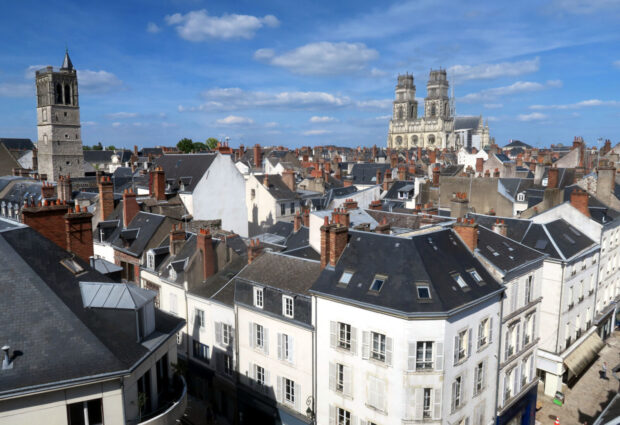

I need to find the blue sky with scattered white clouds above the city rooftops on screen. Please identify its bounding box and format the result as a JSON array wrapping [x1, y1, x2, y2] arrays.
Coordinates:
[[0, 0, 620, 147]]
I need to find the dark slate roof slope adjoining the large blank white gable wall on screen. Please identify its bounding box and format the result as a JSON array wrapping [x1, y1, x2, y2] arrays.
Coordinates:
[[154, 153, 217, 192]]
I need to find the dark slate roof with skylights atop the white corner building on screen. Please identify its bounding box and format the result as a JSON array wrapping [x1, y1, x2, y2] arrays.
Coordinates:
[[311, 229, 502, 316]]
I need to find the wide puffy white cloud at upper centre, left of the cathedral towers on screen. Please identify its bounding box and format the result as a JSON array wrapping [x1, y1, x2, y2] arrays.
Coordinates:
[[254, 41, 379, 75]]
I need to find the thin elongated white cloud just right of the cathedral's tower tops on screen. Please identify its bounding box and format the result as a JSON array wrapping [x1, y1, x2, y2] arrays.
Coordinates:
[[448, 57, 540, 81]]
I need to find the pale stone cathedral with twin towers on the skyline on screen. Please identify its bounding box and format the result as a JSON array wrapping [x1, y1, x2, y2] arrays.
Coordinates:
[[387, 69, 489, 150]]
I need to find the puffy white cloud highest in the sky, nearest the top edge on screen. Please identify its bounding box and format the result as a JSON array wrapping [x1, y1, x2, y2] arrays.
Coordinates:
[[165, 9, 280, 41]]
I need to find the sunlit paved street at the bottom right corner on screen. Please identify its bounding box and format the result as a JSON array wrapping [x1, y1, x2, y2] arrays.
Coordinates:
[[536, 331, 620, 425]]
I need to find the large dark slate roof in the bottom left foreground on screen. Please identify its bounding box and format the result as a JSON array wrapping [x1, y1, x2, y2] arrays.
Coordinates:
[[0, 226, 184, 398]]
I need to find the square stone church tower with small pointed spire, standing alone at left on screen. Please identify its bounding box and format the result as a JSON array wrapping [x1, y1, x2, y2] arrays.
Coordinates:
[[36, 52, 84, 181]]
